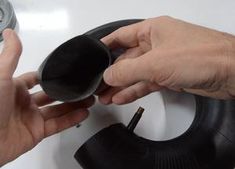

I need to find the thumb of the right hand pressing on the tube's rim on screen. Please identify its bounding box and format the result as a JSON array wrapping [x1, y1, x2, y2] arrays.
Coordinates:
[[103, 53, 151, 86]]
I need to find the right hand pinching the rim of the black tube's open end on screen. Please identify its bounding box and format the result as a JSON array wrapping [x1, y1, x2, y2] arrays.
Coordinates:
[[99, 16, 235, 104]]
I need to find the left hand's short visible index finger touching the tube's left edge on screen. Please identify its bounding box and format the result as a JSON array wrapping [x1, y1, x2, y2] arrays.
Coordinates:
[[16, 72, 39, 89]]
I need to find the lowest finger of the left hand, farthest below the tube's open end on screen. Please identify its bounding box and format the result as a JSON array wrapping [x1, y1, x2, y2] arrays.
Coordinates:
[[45, 109, 89, 137]]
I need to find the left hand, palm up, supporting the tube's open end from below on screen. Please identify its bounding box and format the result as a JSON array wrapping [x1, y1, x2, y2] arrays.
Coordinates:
[[0, 30, 94, 166]]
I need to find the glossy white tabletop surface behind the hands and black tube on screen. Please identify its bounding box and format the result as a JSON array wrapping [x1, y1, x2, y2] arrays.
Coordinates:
[[0, 0, 235, 169]]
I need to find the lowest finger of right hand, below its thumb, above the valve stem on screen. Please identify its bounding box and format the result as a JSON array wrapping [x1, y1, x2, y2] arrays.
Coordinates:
[[112, 81, 161, 105]]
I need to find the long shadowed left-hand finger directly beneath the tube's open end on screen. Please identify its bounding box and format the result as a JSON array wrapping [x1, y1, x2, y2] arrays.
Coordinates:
[[41, 97, 95, 121]]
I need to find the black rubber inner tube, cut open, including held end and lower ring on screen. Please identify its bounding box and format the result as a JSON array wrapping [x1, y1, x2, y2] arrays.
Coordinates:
[[38, 20, 235, 169]]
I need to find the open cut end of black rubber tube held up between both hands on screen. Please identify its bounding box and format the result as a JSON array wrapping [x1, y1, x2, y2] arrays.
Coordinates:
[[38, 20, 143, 102]]
